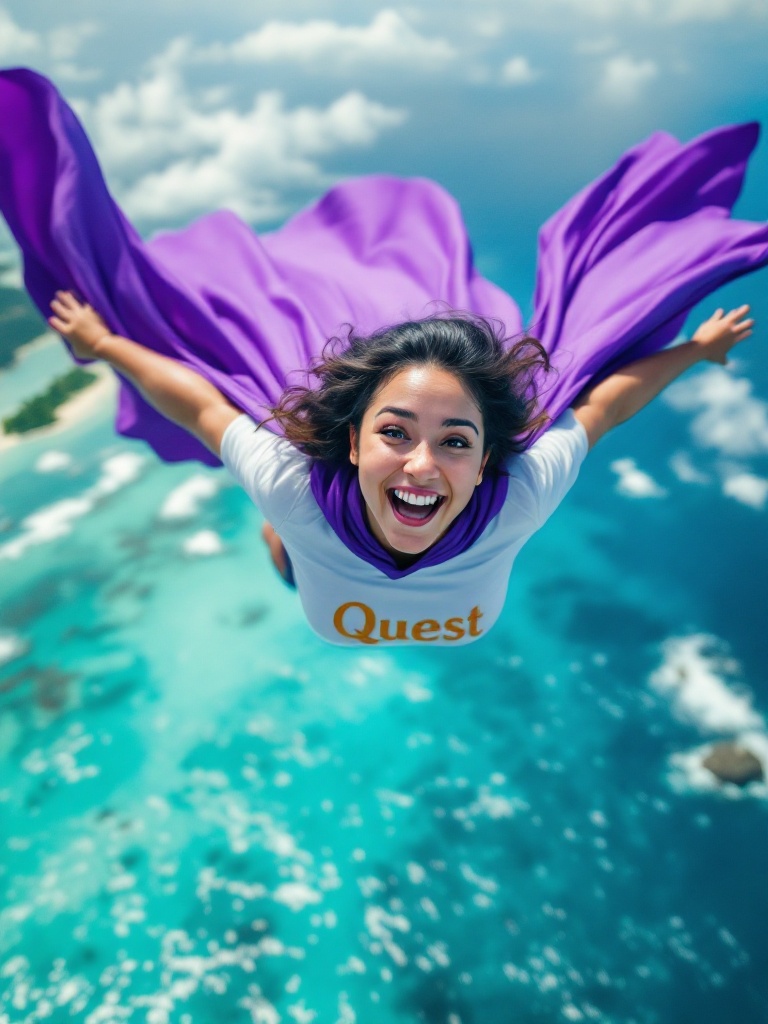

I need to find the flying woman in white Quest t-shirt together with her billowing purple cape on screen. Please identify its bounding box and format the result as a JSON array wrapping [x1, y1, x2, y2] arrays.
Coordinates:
[[0, 71, 768, 645]]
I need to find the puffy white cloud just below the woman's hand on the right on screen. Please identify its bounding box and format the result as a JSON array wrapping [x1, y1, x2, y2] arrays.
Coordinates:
[[664, 367, 768, 457]]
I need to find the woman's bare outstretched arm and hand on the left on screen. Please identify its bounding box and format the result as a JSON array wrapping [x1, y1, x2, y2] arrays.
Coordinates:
[[48, 292, 241, 456]]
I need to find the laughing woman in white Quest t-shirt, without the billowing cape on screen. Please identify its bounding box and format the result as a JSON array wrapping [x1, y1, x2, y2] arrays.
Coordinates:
[[49, 292, 753, 646]]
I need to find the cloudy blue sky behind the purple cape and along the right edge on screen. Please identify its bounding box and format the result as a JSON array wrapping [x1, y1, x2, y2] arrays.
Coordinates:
[[0, 0, 768, 509]]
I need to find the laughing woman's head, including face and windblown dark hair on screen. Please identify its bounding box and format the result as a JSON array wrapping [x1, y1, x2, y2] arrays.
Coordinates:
[[273, 314, 549, 568]]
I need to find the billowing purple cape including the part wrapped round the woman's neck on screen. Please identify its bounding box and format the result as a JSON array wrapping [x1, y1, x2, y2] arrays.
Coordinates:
[[0, 70, 768, 578]]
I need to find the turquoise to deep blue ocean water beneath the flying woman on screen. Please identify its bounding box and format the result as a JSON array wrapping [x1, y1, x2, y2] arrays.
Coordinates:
[[0, 329, 768, 1024]]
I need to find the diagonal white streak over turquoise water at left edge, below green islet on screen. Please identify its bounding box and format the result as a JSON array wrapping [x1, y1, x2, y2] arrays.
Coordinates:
[[0, 452, 144, 558]]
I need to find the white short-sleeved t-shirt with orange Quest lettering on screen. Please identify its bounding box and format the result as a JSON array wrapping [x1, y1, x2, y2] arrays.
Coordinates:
[[221, 410, 589, 647]]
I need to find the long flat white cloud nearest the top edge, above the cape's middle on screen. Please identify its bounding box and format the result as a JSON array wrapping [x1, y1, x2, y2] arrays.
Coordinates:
[[201, 10, 456, 71]]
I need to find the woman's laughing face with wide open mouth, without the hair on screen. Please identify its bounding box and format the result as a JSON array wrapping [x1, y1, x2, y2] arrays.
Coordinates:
[[349, 366, 487, 556]]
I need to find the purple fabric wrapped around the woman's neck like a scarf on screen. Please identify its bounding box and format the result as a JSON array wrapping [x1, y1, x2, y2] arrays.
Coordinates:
[[309, 462, 509, 580]]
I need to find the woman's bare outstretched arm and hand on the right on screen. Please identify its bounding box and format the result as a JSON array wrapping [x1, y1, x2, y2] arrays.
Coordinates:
[[573, 306, 754, 447]]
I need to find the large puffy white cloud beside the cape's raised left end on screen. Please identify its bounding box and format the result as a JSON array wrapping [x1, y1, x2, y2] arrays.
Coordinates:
[[80, 65, 406, 222]]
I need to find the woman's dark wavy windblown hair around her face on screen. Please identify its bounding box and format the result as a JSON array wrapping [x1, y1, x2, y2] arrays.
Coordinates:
[[271, 312, 550, 466]]
